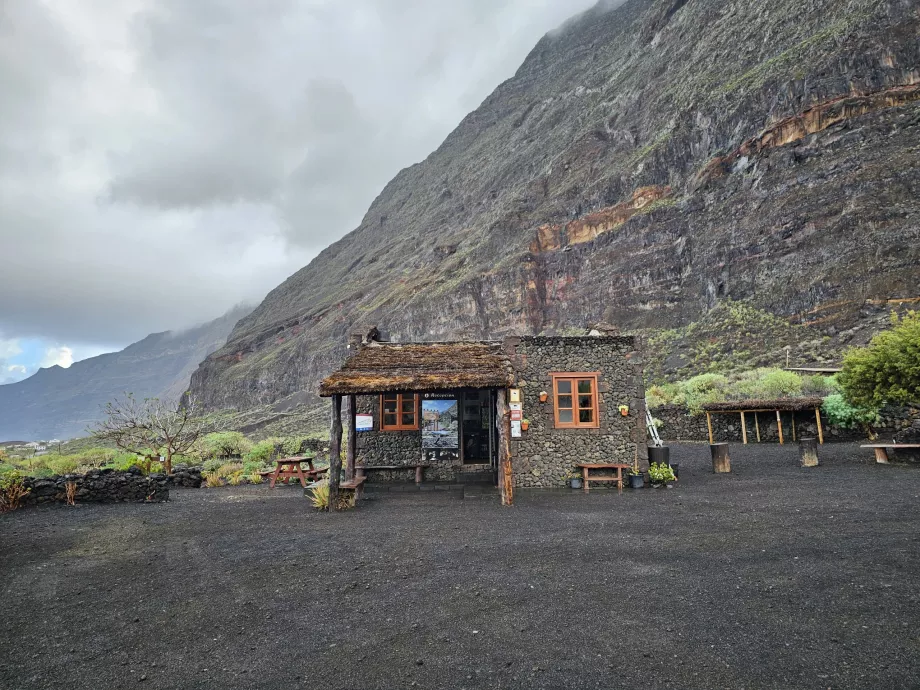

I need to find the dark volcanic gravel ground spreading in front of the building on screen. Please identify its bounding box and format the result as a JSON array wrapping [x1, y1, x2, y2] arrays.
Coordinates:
[[0, 445, 920, 690]]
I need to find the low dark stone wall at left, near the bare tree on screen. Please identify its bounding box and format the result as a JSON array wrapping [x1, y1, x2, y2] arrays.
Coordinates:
[[22, 468, 169, 506]]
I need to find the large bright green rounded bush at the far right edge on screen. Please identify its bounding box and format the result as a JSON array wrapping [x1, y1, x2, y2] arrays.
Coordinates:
[[838, 311, 920, 409]]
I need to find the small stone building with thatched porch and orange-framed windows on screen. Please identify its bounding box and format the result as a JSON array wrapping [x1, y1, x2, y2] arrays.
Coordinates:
[[320, 330, 647, 504]]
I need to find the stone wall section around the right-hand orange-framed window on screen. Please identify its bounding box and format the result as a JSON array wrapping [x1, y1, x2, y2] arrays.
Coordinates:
[[506, 336, 645, 488]]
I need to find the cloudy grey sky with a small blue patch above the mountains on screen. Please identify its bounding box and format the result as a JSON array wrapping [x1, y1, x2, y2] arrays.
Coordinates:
[[0, 0, 593, 382]]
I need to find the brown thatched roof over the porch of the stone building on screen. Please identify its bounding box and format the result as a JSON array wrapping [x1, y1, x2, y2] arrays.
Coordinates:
[[319, 342, 514, 397]]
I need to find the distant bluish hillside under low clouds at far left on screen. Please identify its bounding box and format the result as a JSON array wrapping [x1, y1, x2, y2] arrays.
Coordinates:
[[0, 307, 252, 440]]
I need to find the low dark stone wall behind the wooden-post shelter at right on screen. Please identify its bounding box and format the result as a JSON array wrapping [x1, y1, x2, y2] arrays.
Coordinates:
[[652, 405, 920, 443]]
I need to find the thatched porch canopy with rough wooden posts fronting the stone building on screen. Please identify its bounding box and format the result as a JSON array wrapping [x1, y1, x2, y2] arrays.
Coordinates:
[[319, 340, 514, 509]]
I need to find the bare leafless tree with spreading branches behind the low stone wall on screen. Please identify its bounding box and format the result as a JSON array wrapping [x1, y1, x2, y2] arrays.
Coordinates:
[[89, 393, 202, 474]]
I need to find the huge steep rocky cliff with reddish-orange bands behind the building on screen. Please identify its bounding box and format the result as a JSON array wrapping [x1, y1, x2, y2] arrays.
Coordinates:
[[192, 0, 920, 410]]
